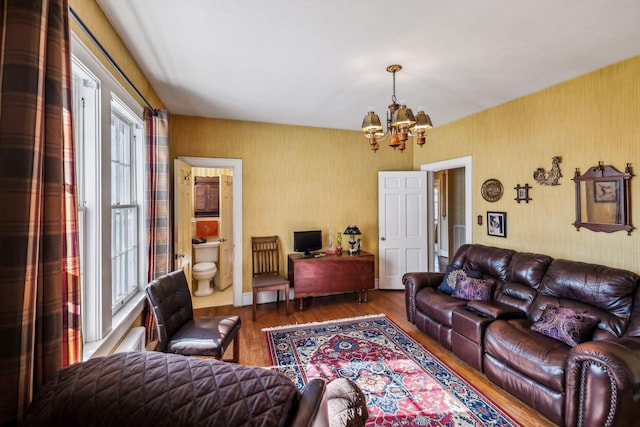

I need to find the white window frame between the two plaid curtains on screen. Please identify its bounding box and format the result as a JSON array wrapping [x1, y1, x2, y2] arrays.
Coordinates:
[[72, 34, 148, 360]]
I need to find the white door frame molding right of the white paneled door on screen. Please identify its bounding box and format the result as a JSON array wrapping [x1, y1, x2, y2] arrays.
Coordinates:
[[420, 156, 473, 271]]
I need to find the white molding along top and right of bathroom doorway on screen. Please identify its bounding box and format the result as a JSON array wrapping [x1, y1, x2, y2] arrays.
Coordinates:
[[178, 156, 243, 307]]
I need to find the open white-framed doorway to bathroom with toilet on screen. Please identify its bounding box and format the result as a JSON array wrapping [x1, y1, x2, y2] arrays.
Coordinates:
[[174, 157, 242, 308]]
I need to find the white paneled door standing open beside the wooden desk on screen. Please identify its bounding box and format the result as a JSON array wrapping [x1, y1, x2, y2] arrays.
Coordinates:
[[378, 171, 428, 289]]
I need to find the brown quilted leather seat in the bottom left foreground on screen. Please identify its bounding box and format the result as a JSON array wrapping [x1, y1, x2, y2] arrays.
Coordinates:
[[25, 352, 367, 427]]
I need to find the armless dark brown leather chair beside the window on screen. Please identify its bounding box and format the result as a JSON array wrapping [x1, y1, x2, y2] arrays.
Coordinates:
[[145, 270, 241, 363]]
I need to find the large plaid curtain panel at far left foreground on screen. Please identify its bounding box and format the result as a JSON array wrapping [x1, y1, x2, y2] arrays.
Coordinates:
[[0, 0, 82, 425]]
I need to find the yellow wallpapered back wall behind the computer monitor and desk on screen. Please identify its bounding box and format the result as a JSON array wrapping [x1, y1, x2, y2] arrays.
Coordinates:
[[170, 115, 412, 291]]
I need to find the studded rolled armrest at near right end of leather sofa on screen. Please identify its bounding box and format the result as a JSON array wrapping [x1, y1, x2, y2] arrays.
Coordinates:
[[565, 337, 640, 427]]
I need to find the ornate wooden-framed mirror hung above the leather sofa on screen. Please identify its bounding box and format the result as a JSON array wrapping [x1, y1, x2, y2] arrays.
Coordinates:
[[572, 162, 635, 235]]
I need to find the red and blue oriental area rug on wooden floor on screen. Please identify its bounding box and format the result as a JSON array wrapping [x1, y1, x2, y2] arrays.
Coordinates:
[[263, 315, 520, 427]]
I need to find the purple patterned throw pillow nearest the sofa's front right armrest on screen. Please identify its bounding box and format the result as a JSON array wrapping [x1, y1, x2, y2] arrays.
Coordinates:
[[531, 305, 600, 347]]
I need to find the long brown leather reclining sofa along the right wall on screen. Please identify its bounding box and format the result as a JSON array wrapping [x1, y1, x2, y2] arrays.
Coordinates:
[[403, 244, 640, 427]]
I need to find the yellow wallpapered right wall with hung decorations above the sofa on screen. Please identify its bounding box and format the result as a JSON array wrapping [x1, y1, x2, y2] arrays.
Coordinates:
[[413, 56, 640, 272]]
